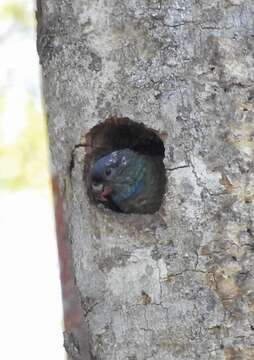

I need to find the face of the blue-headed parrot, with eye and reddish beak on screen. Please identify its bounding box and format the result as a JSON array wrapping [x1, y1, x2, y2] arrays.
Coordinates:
[[91, 151, 126, 202]]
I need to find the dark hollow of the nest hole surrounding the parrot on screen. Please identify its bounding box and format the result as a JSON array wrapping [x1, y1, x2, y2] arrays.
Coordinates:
[[84, 117, 166, 213]]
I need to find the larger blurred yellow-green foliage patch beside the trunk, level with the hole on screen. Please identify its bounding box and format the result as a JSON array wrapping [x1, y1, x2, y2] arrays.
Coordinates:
[[0, 101, 48, 190]]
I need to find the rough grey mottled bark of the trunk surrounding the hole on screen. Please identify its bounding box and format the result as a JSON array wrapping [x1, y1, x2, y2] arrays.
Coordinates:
[[38, 0, 254, 360]]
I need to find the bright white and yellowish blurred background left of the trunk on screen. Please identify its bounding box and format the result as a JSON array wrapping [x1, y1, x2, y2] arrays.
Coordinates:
[[0, 0, 64, 360]]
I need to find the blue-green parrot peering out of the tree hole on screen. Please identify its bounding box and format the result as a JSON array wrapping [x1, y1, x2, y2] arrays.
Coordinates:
[[89, 148, 166, 214]]
